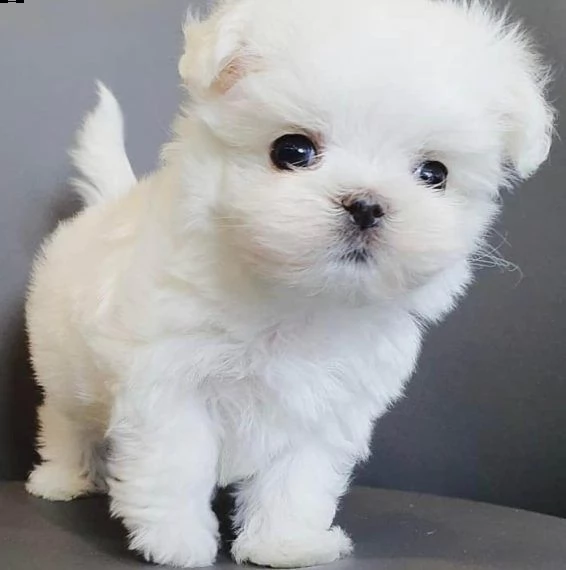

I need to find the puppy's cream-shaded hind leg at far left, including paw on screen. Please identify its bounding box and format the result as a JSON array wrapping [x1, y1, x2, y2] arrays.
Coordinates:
[[26, 396, 103, 501]]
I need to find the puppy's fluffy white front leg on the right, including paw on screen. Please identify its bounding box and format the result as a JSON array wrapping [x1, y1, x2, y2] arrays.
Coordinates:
[[232, 445, 353, 568]]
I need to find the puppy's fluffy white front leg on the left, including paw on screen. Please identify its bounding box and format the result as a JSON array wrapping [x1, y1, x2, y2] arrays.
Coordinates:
[[108, 372, 218, 568]]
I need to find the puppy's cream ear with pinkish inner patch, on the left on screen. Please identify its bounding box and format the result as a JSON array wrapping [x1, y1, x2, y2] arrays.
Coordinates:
[[179, 0, 253, 96]]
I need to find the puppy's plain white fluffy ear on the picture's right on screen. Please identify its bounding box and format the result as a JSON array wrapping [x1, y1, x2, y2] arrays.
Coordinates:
[[504, 36, 555, 179]]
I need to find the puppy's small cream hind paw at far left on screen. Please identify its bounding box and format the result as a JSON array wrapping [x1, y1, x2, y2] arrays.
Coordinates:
[[26, 461, 96, 501]]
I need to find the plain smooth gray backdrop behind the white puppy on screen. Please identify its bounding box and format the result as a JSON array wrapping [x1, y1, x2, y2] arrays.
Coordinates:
[[0, 0, 566, 516]]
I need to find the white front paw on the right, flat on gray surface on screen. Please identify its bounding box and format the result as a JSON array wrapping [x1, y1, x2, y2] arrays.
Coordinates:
[[232, 527, 352, 568]]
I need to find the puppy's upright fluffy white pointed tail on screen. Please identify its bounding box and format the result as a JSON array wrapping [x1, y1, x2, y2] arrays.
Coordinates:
[[71, 82, 137, 206]]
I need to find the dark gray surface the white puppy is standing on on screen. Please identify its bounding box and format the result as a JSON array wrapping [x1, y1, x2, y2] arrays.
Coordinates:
[[0, 484, 566, 570]]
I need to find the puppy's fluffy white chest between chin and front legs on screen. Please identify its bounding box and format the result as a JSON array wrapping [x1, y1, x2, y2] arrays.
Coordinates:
[[204, 312, 420, 483]]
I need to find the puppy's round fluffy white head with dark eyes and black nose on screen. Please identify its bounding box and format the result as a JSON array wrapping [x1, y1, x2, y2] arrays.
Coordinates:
[[180, 0, 553, 298]]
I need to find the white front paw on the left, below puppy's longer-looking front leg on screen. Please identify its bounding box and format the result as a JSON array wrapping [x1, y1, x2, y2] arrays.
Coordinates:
[[129, 521, 218, 568]]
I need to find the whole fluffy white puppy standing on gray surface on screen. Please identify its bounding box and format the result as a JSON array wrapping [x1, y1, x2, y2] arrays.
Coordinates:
[[27, 0, 553, 567]]
